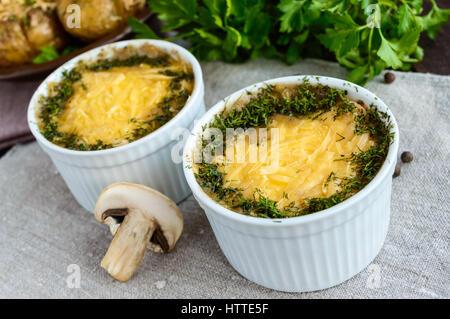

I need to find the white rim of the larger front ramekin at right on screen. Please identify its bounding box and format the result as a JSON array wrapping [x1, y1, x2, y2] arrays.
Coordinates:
[[183, 75, 399, 227]]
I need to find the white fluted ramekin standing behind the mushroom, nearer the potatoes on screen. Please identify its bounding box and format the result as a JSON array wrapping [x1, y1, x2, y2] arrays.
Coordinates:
[[28, 40, 205, 212]]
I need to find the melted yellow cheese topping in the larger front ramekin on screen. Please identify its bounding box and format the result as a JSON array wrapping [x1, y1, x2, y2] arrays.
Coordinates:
[[215, 109, 375, 208]]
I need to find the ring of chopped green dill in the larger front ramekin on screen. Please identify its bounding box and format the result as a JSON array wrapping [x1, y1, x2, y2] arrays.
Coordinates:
[[195, 81, 393, 218]]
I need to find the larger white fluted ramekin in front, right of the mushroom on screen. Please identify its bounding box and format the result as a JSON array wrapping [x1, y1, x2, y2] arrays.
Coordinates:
[[183, 76, 399, 292]]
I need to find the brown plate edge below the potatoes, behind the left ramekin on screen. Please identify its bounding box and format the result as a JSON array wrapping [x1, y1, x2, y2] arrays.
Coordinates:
[[0, 8, 151, 80]]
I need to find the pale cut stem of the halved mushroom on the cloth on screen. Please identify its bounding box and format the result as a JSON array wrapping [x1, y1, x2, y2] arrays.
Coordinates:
[[101, 214, 157, 282]]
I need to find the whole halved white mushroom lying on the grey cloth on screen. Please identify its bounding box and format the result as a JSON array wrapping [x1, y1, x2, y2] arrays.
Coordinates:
[[94, 183, 183, 281]]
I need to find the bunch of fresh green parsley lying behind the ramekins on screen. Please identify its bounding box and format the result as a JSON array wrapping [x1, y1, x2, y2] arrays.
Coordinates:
[[130, 0, 450, 84]]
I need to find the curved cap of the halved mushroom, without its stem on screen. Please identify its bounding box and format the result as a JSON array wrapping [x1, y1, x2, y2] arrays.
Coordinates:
[[94, 182, 183, 252]]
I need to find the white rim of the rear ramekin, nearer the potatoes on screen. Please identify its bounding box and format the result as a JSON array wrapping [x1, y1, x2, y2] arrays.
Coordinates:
[[27, 39, 204, 158]]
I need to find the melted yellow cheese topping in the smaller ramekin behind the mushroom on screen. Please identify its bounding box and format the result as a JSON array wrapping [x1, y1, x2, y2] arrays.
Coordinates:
[[58, 65, 189, 146]]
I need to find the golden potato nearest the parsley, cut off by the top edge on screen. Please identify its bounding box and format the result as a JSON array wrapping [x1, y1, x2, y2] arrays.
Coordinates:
[[57, 0, 146, 42]]
